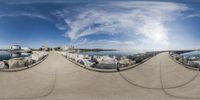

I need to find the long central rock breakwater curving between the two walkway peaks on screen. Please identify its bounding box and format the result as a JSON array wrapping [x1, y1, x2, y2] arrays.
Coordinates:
[[58, 52, 155, 69]]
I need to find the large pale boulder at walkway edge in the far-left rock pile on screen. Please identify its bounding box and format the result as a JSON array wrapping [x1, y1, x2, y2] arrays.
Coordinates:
[[8, 59, 26, 69]]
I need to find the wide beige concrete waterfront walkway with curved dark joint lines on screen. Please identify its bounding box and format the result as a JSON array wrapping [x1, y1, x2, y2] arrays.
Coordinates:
[[0, 53, 200, 100]]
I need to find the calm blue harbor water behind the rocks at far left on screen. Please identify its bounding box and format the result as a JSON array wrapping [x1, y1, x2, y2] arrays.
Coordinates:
[[0, 51, 30, 61]]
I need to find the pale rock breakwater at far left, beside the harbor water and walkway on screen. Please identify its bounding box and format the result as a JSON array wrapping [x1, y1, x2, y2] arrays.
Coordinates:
[[0, 52, 48, 70]]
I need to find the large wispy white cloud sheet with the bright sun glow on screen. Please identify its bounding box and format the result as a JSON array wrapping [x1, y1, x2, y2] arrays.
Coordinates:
[[57, 1, 189, 45]]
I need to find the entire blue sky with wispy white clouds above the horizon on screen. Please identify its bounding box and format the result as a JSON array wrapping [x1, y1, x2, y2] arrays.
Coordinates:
[[0, 0, 200, 51]]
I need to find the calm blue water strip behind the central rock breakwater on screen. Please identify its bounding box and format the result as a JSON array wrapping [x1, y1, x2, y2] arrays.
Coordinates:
[[79, 51, 139, 57]]
